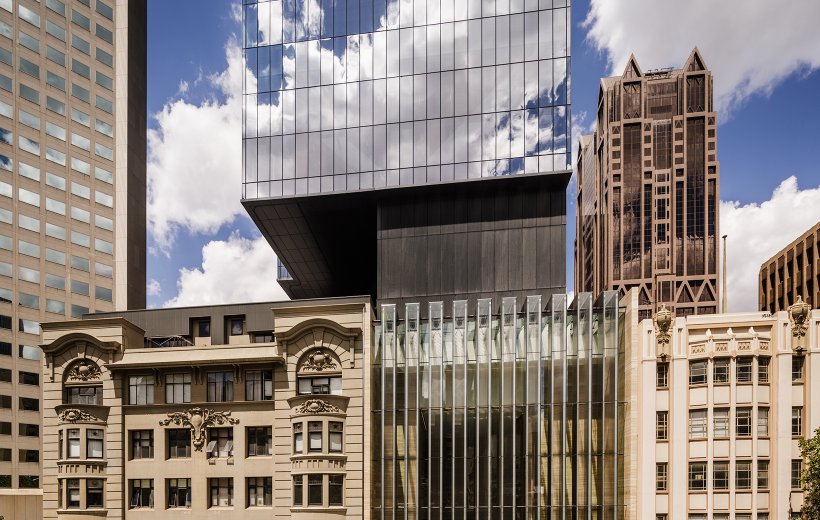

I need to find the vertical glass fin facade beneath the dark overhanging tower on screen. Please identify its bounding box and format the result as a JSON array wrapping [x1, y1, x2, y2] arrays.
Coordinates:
[[371, 292, 625, 520]]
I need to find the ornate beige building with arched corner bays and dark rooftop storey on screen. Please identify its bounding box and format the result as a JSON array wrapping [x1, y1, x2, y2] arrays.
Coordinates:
[[38, 298, 373, 520]]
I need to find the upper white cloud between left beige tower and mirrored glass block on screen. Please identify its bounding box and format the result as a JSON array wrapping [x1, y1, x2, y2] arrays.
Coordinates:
[[148, 40, 245, 254]]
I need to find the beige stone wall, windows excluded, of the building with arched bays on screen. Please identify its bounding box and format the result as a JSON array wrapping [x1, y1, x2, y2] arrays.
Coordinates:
[[43, 304, 371, 520]]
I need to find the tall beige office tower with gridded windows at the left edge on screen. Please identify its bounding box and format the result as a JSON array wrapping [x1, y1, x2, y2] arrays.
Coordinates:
[[0, 0, 146, 519]]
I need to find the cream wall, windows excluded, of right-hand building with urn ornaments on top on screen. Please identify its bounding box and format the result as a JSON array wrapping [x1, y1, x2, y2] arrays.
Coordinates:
[[626, 300, 820, 519]]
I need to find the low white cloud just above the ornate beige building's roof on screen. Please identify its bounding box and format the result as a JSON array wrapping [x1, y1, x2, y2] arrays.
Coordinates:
[[164, 231, 288, 307]]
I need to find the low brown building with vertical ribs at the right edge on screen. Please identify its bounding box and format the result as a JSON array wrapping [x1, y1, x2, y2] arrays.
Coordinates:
[[758, 222, 820, 312]]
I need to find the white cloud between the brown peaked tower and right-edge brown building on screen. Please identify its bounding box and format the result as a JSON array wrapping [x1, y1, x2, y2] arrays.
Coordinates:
[[720, 176, 820, 312]]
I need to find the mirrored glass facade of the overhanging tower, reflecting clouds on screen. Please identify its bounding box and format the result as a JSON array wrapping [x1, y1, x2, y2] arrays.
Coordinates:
[[243, 0, 570, 198]]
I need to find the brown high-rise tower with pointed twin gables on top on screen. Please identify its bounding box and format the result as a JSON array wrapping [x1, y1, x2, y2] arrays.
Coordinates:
[[575, 49, 720, 318]]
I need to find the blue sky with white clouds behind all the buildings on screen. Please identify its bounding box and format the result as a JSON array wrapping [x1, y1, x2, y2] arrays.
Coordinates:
[[147, 0, 820, 312]]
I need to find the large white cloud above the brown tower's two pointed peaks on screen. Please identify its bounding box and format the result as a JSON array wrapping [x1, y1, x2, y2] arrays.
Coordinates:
[[584, 0, 820, 114]]
